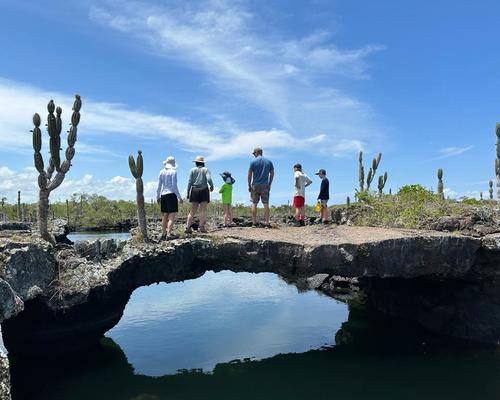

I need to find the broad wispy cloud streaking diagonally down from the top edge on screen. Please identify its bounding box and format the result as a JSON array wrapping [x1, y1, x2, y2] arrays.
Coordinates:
[[89, 0, 383, 150]]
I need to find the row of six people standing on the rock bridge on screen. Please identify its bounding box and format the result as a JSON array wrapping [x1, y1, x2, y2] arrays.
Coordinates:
[[156, 147, 329, 240]]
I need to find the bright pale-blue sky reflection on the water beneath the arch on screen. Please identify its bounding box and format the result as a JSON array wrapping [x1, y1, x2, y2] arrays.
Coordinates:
[[107, 271, 348, 376]]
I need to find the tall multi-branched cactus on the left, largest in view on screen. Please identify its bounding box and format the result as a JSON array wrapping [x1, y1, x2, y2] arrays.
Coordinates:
[[32, 95, 82, 245]]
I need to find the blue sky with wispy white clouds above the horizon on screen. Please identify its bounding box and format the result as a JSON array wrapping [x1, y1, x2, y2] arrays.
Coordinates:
[[0, 0, 500, 204]]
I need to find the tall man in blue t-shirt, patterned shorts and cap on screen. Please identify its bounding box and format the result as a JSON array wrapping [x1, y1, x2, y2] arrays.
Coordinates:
[[248, 147, 274, 228]]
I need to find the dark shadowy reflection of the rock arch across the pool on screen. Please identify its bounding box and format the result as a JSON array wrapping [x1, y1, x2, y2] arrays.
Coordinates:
[[11, 307, 500, 400]]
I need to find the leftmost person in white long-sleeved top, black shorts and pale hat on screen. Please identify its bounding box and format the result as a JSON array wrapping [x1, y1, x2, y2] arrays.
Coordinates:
[[156, 156, 182, 240]]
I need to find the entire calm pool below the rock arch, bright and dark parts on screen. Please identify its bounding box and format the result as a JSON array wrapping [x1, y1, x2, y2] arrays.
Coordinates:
[[6, 271, 500, 400]]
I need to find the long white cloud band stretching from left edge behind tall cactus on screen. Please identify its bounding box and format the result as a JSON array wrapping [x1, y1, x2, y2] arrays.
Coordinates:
[[0, 79, 368, 160]]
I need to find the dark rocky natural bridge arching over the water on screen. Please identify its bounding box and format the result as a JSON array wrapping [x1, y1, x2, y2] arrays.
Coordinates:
[[0, 226, 500, 362]]
